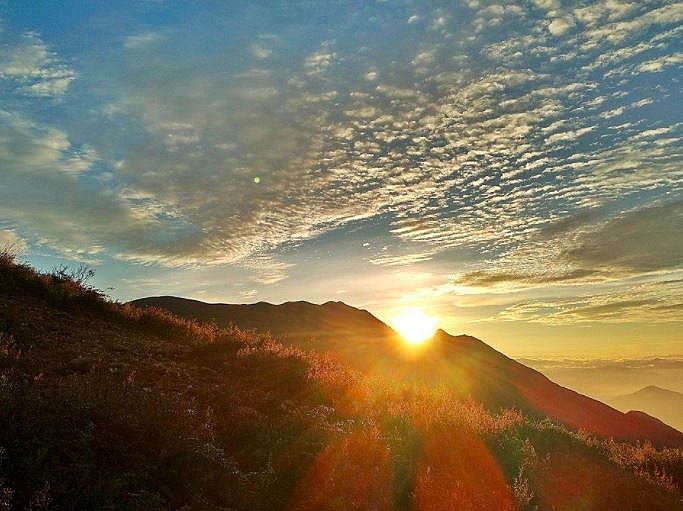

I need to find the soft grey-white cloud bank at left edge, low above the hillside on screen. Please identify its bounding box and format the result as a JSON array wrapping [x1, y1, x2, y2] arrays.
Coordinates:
[[0, 111, 208, 264]]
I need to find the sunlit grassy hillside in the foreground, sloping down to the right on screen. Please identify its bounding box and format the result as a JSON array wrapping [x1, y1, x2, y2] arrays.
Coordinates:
[[0, 254, 683, 510]]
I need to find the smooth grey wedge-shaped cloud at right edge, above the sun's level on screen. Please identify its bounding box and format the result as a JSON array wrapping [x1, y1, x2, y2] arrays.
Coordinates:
[[455, 202, 683, 294]]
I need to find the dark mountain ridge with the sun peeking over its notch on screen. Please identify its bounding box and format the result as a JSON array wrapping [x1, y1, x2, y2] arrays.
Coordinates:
[[132, 296, 683, 446]]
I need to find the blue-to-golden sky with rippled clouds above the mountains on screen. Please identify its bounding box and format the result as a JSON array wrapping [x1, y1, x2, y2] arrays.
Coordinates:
[[0, 0, 683, 358]]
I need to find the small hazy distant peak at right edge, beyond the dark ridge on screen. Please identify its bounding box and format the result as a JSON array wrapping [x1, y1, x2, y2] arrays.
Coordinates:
[[609, 385, 683, 430]]
